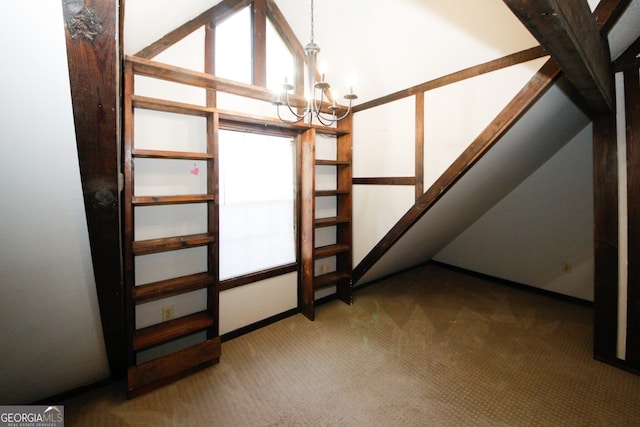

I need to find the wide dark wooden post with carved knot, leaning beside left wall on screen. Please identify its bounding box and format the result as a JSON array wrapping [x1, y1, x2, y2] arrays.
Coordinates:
[[62, 0, 126, 377]]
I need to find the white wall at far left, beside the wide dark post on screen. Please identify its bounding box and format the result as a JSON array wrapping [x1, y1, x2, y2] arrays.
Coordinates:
[[0, 0, 109, 404]]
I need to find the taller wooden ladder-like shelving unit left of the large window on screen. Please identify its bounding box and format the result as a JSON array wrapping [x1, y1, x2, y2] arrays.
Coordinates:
[[123, 63, 220, 397]]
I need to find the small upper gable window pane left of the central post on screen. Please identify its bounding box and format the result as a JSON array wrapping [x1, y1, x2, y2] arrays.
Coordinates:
[[215, 7, 252, 83]]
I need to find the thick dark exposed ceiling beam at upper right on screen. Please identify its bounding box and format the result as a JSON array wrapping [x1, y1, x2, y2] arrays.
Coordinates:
[[503, 0, 614, 113]]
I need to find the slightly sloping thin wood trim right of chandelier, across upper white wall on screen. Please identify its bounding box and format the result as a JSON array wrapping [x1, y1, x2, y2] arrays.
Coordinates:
[[353, 46, 548, 113]]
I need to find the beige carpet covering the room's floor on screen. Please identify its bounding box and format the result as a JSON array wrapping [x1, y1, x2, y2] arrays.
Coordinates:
[[65, 265, 640, 426]]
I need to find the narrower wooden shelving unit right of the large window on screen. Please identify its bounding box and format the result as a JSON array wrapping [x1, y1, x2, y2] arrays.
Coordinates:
[[299, 116, 353, 320]]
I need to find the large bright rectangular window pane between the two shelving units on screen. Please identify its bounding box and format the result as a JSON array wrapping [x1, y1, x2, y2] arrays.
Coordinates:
[[219, 131, 295, 280]]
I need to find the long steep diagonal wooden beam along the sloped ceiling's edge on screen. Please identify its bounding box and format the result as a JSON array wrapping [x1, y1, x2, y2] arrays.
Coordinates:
[[353, 60, 560, 283]]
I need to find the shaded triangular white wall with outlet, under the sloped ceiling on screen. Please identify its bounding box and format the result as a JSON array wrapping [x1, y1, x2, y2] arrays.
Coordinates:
[[434, 125, 593, 301]]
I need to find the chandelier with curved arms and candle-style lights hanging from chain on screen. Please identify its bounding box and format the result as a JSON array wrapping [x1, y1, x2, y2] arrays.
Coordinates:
[[272, 0, 358, 126]]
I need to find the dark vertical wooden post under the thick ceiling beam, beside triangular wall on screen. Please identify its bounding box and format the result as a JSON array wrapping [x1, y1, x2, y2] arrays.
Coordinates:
[[593, 114, 618, 361]]
